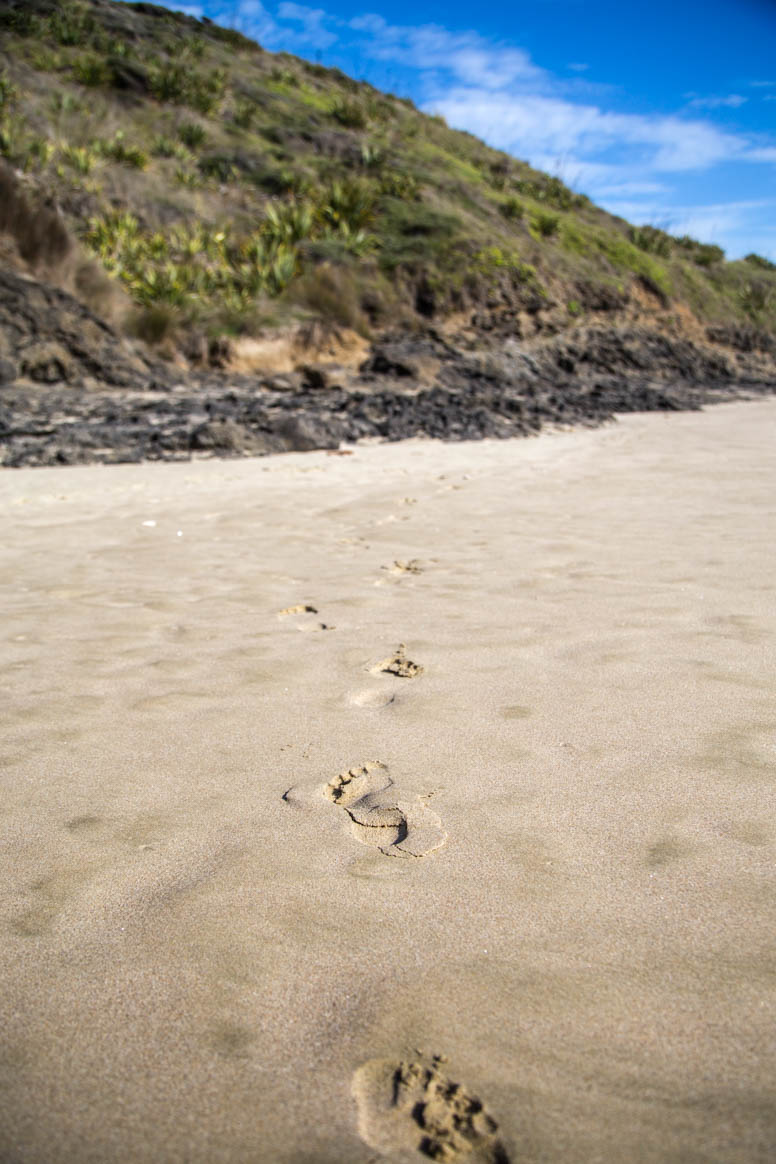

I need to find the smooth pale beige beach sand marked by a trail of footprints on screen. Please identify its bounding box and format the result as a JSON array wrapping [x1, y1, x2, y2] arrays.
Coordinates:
[[0, 400, 776, 1164]]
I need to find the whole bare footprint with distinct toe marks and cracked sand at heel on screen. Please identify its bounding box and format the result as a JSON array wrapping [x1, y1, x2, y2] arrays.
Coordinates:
[[323, 760, 447, 857]]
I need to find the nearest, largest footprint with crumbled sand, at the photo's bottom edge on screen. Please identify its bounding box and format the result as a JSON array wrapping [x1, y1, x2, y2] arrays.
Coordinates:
[[351, 1056, 510, 1164]]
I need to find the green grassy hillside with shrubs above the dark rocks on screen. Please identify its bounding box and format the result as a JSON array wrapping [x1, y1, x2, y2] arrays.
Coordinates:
[[0, 0, 776, 351]]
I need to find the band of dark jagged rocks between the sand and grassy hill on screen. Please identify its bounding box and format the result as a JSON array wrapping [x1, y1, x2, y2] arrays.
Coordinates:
[[0, 271, 776, 466]]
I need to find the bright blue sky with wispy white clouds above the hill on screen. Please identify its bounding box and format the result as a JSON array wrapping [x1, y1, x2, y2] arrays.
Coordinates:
[[160, 0, 776, 261]]
